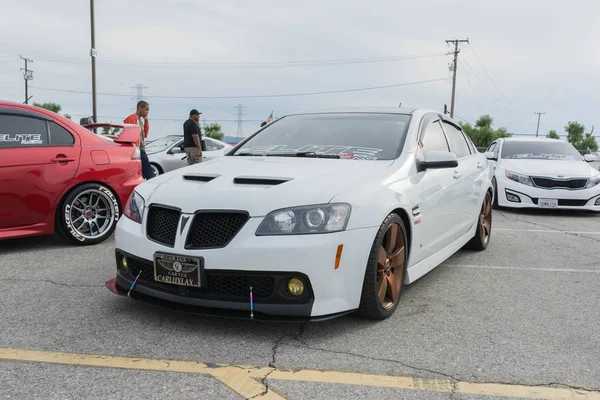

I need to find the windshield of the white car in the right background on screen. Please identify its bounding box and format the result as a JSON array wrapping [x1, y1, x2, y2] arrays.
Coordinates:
[[501, 140, 582, 160]]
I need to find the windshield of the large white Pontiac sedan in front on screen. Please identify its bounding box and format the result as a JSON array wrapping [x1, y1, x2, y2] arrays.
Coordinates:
[[232, 113, 410, 160]]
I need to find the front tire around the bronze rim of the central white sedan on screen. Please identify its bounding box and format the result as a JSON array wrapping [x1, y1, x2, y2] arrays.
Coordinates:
[[356, 213, 408, 320]]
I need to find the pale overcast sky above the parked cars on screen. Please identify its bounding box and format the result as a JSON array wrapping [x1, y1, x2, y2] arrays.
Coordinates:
[[0, 0, 600, 138]]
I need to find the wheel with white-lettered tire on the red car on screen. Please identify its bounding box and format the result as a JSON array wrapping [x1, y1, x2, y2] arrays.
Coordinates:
[[56, 183, 121, 246]]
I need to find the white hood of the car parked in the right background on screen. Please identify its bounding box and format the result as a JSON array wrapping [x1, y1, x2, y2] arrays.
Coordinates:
[[502, 159, 598, 178]]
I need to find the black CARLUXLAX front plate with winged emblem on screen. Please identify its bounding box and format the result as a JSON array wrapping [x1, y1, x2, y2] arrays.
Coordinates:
[[154, 253, 201, 287]]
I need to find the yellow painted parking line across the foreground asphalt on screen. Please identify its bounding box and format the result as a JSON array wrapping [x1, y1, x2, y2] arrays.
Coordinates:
[[0, 348, 600, 400]]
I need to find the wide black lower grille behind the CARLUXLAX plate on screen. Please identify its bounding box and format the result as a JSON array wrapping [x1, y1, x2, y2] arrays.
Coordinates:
[[127, 257, 275, 300]]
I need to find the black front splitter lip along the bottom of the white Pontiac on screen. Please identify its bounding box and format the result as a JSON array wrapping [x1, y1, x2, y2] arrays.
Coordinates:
[[105, 278, 355, 323]]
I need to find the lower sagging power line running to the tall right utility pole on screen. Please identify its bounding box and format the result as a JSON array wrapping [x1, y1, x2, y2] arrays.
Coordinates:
[[29, 78, 448, 99]]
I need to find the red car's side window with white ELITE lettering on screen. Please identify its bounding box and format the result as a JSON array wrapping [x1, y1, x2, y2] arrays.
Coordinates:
[[0, 114, 48, 149]]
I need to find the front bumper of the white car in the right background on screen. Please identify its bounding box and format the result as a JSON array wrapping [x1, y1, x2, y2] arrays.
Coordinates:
[[496, 178, 600, 211]]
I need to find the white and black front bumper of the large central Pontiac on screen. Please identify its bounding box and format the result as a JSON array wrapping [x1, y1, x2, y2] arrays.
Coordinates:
[[107, 217, 378, 321]]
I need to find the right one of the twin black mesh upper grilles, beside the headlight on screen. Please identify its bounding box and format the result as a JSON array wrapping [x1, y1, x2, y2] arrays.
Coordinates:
[[185, 211, 249, 249]]
